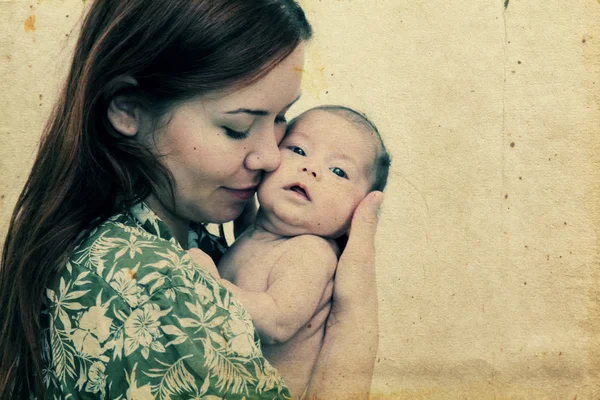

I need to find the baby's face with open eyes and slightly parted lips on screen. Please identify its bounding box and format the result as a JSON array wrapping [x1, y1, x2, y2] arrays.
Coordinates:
[[258, 110, 376, 238]]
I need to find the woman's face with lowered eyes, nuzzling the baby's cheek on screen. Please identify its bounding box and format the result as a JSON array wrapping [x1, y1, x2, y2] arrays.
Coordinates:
[[138, 44, 304, 230]]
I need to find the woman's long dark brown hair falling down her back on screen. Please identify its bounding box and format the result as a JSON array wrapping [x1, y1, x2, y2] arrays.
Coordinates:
[[0, 0, 311, 399]]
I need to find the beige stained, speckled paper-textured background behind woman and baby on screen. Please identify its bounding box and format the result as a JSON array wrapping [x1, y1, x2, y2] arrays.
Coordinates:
[[0, 0, 600, 400]]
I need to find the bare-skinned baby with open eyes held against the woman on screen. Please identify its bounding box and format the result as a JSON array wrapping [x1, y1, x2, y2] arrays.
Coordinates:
[[218, 106, 390, 398]]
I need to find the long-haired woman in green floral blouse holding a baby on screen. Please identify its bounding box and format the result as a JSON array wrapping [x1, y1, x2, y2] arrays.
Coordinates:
[[0, 0, 381, 398]]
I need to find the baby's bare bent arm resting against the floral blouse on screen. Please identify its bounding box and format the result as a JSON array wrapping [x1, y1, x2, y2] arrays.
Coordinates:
[[222, 235, 337, 344]]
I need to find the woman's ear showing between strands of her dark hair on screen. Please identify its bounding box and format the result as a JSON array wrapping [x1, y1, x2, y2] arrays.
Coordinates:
[[107, 77, 141, 137]]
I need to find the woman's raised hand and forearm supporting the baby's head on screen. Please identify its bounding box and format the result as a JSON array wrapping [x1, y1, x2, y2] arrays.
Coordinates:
[[306, 192, 383, 399]]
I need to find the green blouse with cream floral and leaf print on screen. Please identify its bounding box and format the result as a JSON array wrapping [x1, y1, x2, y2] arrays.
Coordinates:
[[42, 203, 290, 399]]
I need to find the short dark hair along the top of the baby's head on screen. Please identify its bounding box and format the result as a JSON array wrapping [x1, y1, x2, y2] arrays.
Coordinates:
[[287, 105, 392, 191]]
